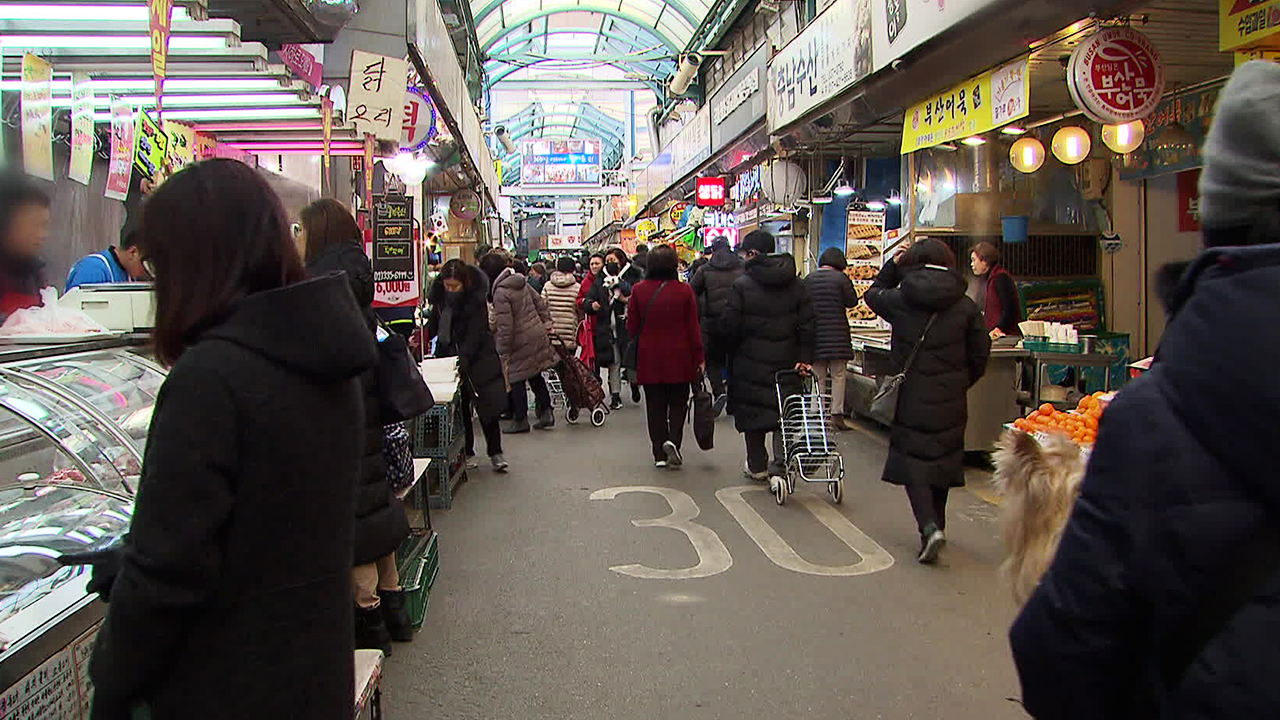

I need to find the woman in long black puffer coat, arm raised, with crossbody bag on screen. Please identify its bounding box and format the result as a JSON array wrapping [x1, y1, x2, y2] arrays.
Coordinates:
[[867, 240, 991, 562]]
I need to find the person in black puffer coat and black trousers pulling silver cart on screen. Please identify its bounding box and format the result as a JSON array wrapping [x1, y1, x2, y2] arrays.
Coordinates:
[[721, 231, 813, 491]]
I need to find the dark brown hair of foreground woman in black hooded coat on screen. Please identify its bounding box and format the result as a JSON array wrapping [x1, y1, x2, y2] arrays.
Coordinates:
[[141, 159, 307, 366]]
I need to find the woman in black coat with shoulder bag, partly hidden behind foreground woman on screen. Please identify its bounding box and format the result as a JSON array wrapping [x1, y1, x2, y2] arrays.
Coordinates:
[[298, 199, 413, 655]]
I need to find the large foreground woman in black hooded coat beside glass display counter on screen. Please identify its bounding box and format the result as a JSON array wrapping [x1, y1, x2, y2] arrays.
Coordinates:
[[82, 160, 378, 720]]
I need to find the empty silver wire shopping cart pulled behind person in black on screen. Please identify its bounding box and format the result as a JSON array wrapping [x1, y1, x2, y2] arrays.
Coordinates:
[[772, 370, 845, 505]]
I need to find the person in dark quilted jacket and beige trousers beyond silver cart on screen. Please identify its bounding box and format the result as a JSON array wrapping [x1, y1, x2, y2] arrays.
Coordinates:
[[804, 247, 858, 429]]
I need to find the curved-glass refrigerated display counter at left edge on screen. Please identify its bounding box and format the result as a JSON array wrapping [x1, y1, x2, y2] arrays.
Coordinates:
[[0, 338, 165, 720]]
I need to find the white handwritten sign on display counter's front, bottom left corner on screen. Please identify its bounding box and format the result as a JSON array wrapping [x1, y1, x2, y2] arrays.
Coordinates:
[[0, 625, 97, 720]]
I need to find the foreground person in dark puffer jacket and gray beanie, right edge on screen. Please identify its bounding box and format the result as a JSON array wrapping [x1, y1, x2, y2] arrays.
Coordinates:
[[1010, 60, 1280, 720]]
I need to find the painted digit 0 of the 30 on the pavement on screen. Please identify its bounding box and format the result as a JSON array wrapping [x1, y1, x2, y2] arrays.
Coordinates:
[[716, 486, 893, 577]]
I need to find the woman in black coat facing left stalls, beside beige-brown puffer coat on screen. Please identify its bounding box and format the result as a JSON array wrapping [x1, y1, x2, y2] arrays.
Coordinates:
[[426, 259, 508, 473]]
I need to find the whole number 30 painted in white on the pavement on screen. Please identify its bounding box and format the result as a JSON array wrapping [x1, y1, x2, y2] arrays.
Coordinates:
[[591, 486, 893, 580]]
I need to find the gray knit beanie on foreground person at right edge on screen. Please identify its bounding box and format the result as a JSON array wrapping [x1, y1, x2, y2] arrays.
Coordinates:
[[1199, 60, 1280, 247]]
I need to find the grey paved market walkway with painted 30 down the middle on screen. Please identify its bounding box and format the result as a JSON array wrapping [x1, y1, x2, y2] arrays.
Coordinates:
[[383, 404, 1025, 720]]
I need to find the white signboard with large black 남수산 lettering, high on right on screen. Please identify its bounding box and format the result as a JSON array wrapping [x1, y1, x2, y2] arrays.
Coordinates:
[[767, 0, 872, 132]]
